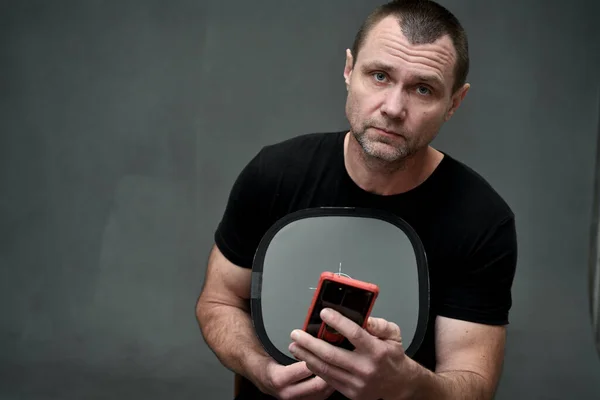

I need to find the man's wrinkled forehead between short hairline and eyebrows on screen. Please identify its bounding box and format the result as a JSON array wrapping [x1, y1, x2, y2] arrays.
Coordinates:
[[357, 16, 456, 86]]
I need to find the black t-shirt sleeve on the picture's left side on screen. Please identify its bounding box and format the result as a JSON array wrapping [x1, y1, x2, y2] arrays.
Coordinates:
[[214, 151, 267, 268]]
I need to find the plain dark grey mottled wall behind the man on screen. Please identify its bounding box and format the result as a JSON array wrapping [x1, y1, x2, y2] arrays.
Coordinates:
[[0, 0, 600, 399]]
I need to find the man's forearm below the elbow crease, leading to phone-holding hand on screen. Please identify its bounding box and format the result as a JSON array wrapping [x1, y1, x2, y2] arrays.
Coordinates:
[[398, 360, 493, 400]]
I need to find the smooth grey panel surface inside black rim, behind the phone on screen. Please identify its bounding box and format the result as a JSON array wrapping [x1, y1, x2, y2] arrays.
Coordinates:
[[261, 216, 419, 357]]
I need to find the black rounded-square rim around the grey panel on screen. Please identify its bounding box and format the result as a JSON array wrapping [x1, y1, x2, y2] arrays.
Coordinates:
[[250, 207, 430, 365]]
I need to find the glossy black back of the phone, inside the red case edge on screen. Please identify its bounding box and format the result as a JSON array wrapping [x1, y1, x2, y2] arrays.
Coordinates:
[[307, 280, 373, 350]]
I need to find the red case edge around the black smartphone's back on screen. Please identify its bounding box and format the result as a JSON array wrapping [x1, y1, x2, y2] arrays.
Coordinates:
[[303, 272, 379, 344]]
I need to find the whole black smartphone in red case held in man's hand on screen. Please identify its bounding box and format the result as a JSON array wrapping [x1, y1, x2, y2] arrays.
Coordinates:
[[303, 272, 379, 350]]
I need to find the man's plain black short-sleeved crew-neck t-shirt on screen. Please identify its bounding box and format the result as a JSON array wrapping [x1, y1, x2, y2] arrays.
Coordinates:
[[215, 132, 517, 398]]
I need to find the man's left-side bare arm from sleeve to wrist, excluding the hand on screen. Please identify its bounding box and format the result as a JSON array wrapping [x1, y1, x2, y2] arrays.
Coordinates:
[[196, 246, 269, 382]]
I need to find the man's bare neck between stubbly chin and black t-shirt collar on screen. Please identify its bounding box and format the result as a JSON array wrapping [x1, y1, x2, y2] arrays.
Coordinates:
[[344, 132, 444, 196]]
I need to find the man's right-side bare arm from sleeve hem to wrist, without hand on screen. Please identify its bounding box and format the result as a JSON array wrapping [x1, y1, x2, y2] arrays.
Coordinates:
[[400, 317, 506, 400]]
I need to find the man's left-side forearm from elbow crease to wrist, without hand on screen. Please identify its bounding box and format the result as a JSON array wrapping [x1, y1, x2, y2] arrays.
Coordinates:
[[196, 301, 269, 381]]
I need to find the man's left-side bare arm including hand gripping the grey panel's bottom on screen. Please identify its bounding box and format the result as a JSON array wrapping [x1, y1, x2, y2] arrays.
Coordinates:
[[196, 246, 334, 400]]
